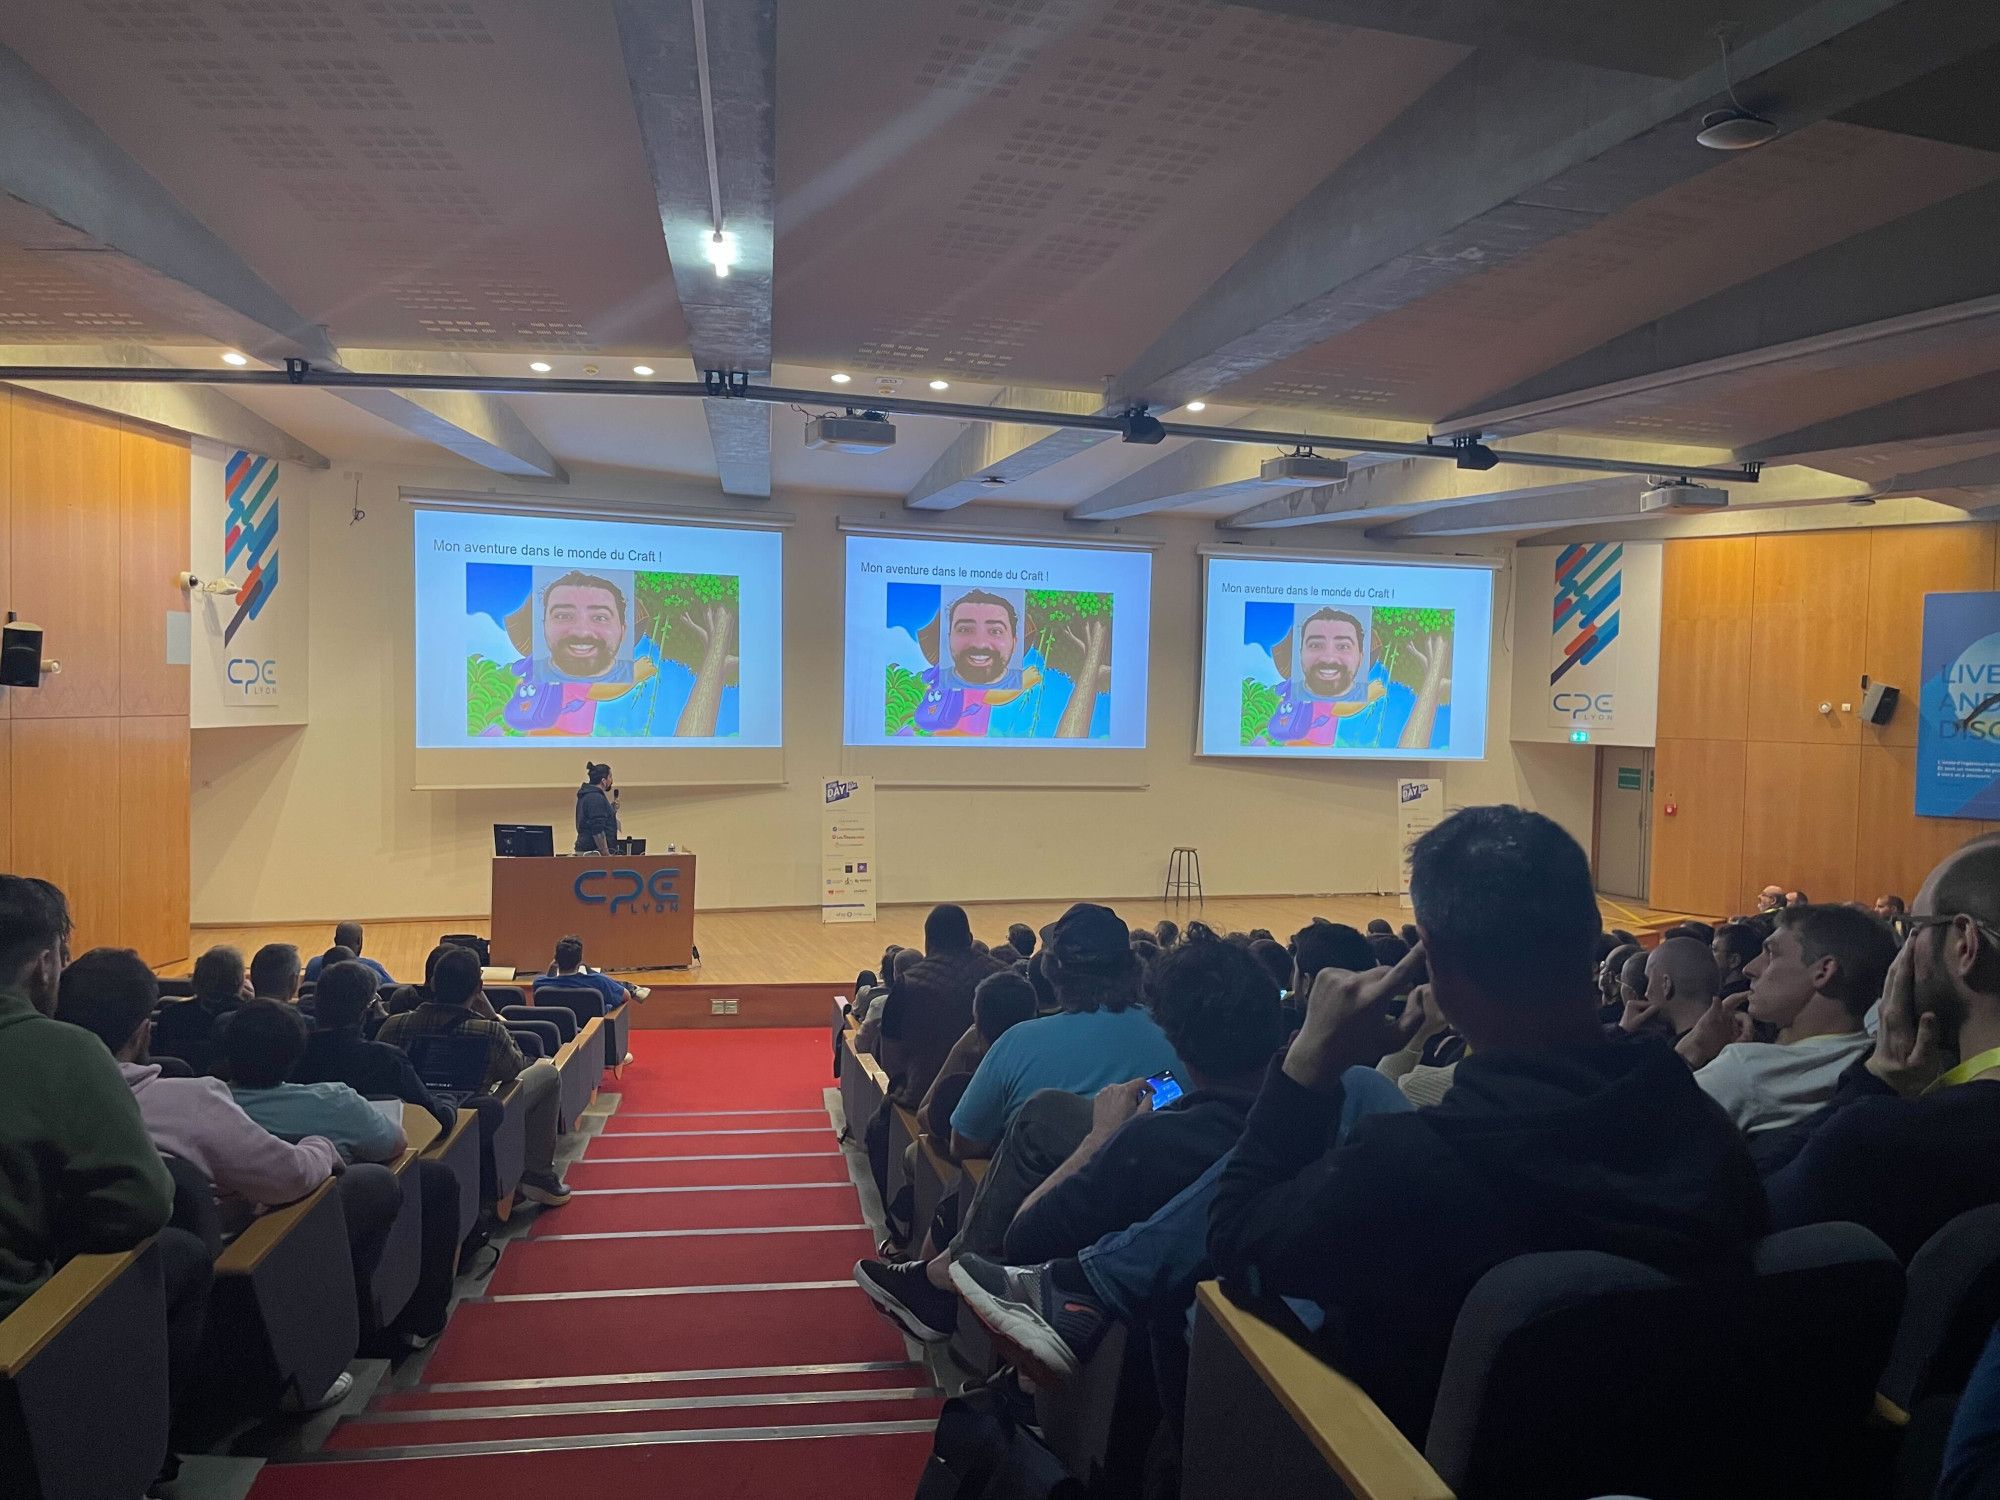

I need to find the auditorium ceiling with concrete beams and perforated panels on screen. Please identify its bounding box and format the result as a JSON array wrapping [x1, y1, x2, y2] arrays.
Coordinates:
[[0, 0, 2000, 542]]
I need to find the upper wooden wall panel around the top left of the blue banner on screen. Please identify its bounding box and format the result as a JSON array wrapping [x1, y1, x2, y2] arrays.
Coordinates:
[[1862, 524, 2000, 746]]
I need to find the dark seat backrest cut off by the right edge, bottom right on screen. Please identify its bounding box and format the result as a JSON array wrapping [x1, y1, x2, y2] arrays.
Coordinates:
[[1882, 1204, 2000, 1412]]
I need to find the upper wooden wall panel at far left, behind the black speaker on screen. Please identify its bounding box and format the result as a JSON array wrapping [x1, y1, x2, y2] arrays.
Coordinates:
[[8, 392, 120, 724]]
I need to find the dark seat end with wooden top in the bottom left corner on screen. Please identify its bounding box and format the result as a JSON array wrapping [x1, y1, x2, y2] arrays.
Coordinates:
[[0, 1240, 168, 1500]]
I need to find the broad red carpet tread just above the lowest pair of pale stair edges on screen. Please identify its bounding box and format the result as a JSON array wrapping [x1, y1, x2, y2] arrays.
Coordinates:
[[424, 1296, 908, 1384]]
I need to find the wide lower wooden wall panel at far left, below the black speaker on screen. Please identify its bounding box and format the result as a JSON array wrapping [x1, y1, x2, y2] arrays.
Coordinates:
[[12, 716, 122, 952]]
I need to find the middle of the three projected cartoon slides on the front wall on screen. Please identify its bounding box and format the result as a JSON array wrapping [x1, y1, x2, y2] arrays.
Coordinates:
[[846, 536, 1152, 750]]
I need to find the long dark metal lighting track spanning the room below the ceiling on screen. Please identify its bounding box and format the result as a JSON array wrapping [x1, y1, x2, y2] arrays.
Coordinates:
[[0, 360, 1758, 484]]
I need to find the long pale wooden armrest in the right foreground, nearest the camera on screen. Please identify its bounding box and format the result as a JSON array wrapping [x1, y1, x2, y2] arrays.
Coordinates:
[[1196, 1282, 1452, 1500]]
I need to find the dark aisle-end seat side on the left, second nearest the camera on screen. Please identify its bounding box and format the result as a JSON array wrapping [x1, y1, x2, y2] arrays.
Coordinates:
[[208, 1180, 360, 1412]]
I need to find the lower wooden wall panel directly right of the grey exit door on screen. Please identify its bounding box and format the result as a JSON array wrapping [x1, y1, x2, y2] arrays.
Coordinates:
[[1648, 738, 1744, 914]]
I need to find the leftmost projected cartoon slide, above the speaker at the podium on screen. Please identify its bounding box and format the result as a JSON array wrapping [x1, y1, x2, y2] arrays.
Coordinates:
[[414, 508, 784, 754]]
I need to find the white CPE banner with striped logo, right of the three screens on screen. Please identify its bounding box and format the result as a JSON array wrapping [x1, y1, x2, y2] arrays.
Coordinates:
[[1514, 542, 1662, 746]]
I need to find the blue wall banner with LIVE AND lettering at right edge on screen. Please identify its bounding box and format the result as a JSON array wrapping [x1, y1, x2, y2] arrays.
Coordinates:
[[1916, 594, 2000, 818]]
